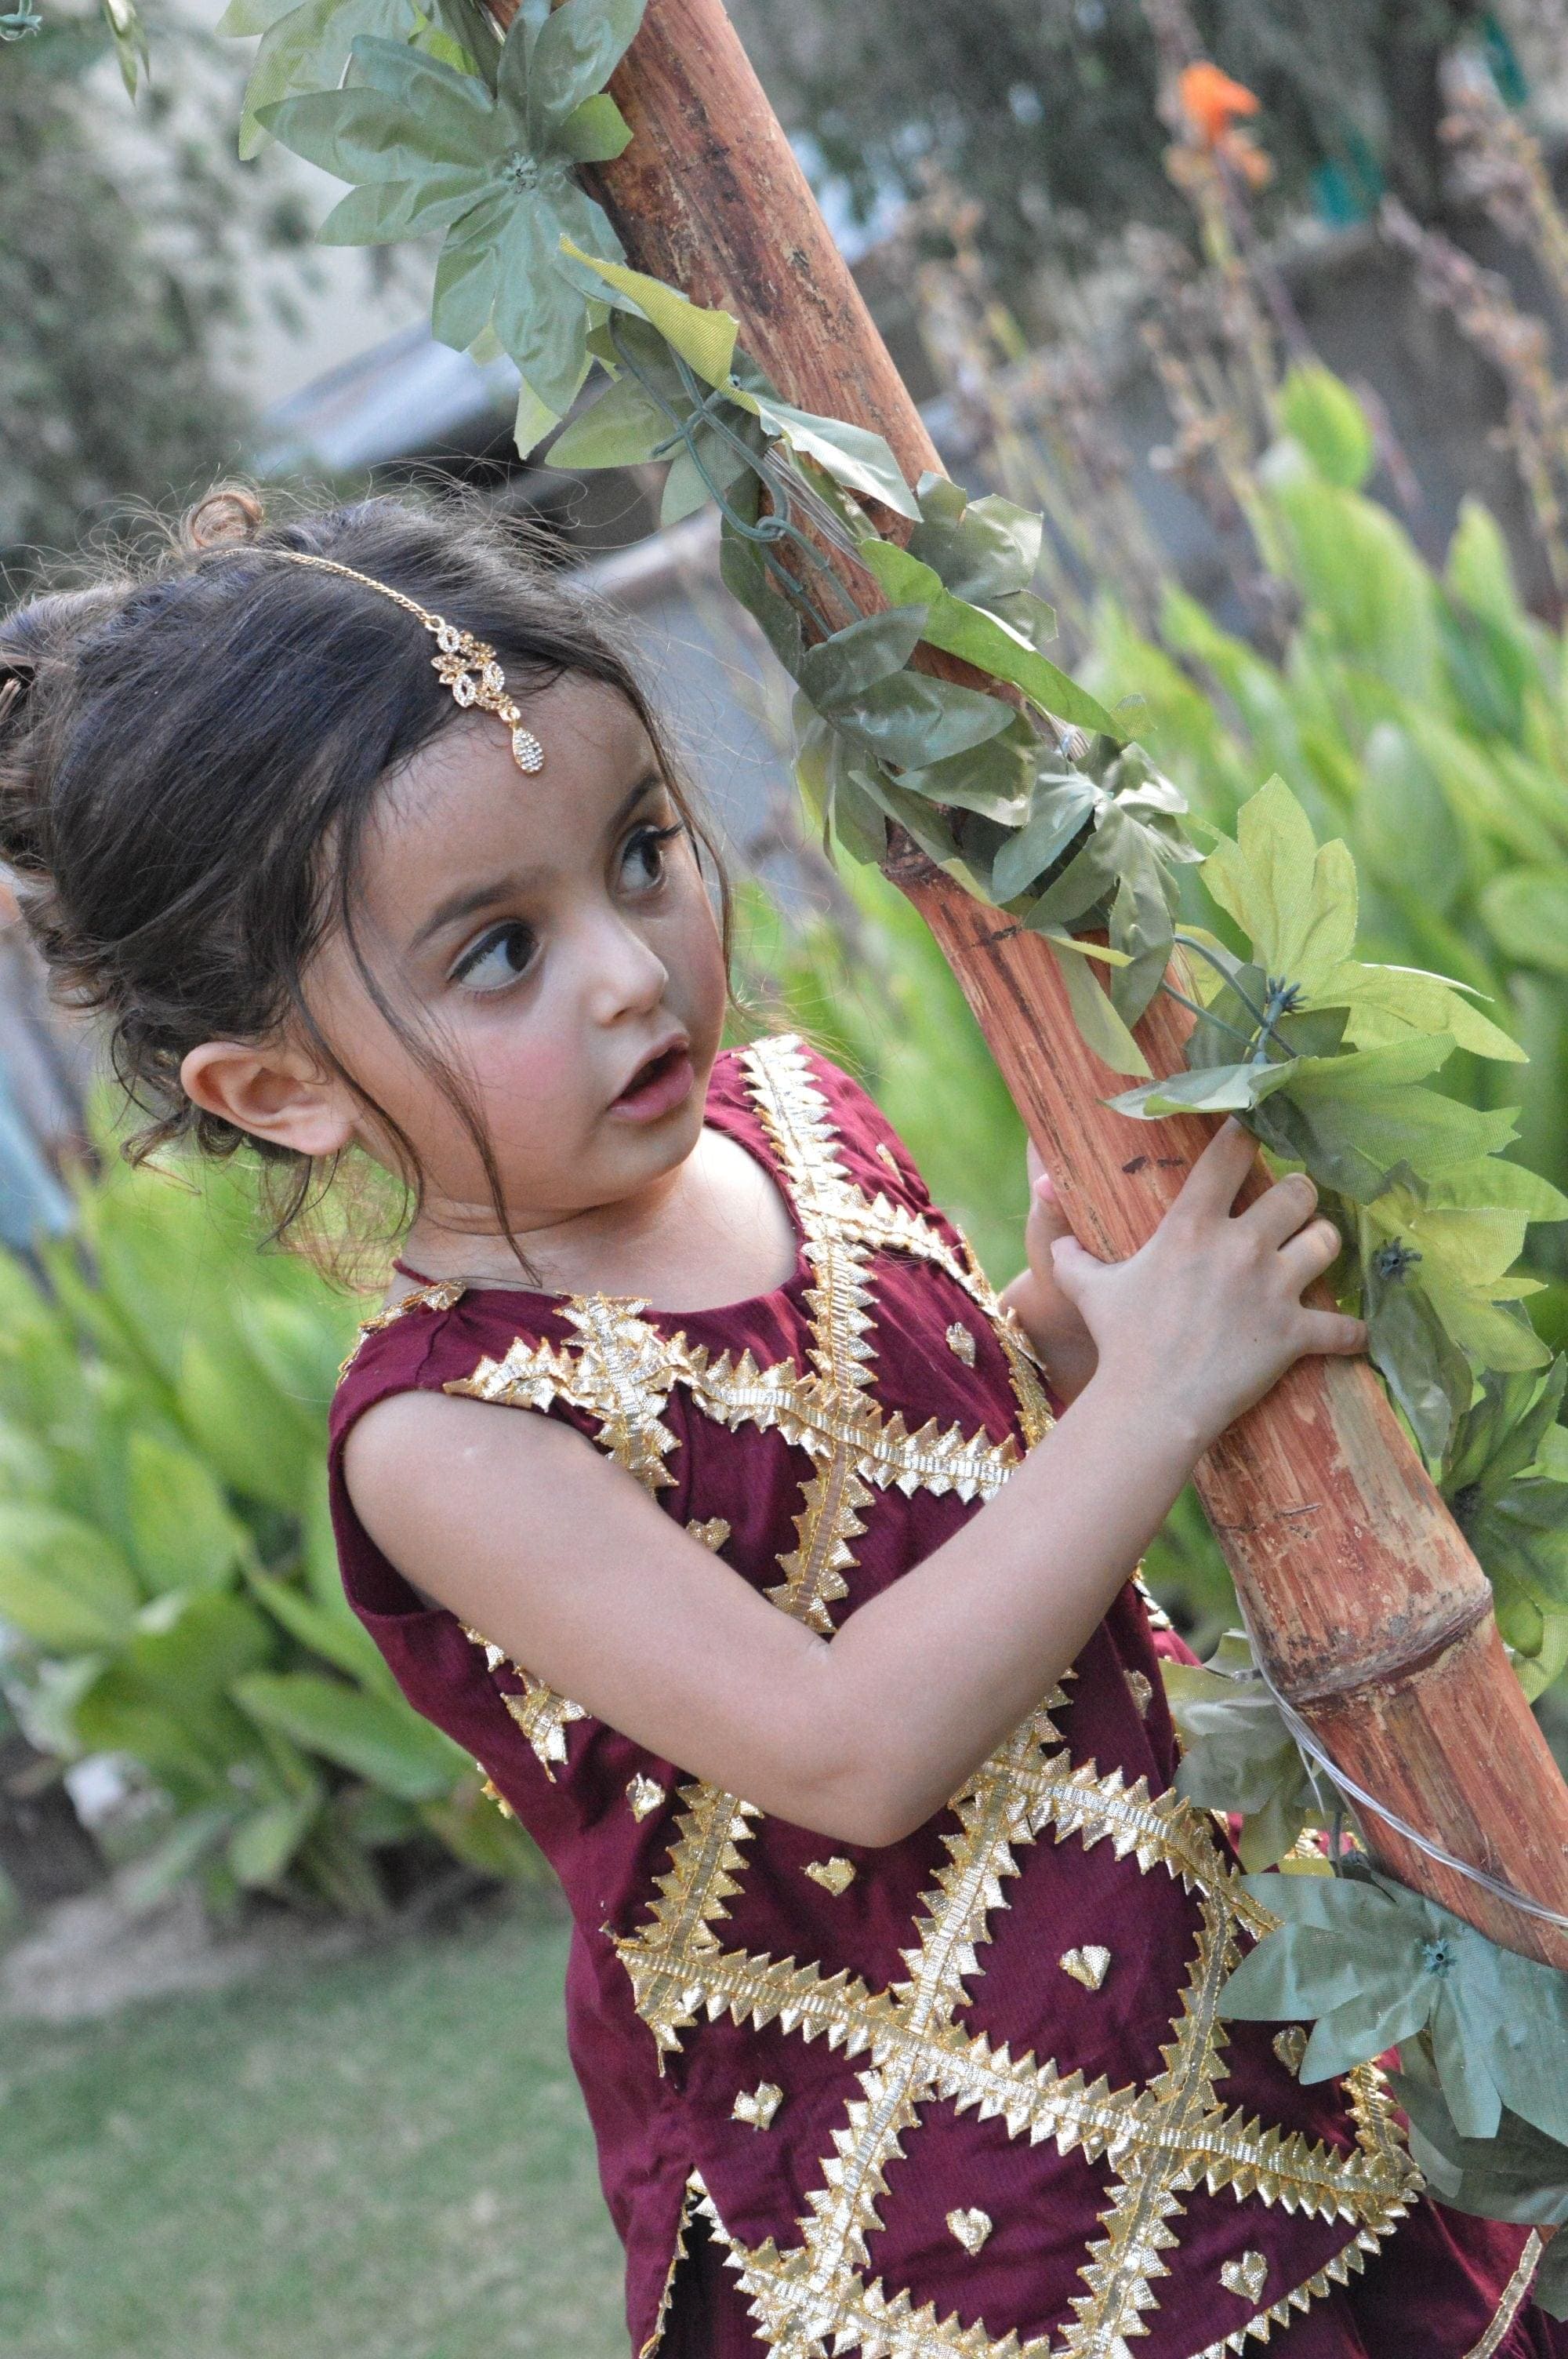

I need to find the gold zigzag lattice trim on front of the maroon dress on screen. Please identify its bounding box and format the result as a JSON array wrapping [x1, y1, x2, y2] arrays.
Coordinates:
[[450, 1041, 1420, 2359]]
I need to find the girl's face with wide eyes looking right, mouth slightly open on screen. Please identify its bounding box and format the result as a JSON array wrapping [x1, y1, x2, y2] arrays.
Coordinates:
[[307, 674, 726, 1236]]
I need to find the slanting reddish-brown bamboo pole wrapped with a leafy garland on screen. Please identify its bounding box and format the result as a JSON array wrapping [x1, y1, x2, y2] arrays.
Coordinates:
[[498, 0, 1568, 1965]]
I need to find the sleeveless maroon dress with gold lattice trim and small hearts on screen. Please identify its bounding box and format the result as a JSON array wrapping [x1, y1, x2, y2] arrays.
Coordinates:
[[332, 1038, 1568, 2359]]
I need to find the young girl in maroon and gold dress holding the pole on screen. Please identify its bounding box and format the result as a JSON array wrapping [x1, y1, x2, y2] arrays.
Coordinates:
[[0, 496, 1568, 2359]]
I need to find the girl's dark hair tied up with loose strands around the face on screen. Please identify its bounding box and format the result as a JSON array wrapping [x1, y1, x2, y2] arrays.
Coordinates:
[[0, 486, 728, 1269]]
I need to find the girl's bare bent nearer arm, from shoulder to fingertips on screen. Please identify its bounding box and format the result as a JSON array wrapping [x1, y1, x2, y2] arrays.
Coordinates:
[[344, 1125, 1365, 1845]]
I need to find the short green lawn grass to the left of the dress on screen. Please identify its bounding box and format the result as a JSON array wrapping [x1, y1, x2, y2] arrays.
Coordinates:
[[0, 1903, 627, 2359]]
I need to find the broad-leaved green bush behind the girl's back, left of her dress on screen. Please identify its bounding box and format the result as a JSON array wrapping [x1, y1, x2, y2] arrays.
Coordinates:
[[0, 1158, 533, 1913]]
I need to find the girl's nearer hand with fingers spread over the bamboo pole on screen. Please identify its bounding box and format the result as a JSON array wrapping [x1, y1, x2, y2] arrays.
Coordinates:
[[1051, 1123, 1367, 1453]]
